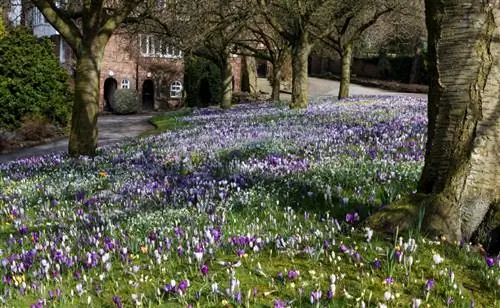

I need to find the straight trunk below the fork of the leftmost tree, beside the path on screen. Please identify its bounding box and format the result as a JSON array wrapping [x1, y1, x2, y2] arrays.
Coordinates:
[[68, 51, 100, 156]]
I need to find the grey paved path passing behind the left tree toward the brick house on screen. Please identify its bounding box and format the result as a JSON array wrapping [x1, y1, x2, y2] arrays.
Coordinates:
[[0, 113, 154, 163]]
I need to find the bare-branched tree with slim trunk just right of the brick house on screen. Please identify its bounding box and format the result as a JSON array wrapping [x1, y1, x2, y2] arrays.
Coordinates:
[[150, 0, 253, 108]]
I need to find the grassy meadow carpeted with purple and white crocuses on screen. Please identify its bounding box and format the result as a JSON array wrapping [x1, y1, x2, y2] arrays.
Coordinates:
[[0, 96, 500, 307]]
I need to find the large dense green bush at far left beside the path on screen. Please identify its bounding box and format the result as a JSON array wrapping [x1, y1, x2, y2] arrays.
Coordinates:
[[0, 27, 72, 130]]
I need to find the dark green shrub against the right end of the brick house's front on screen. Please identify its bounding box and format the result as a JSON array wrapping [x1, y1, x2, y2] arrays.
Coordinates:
[[184, 56, 222, 107]]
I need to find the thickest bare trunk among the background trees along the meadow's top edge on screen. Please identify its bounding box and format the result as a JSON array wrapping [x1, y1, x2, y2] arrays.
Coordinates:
[[291, 34, 312, 108]]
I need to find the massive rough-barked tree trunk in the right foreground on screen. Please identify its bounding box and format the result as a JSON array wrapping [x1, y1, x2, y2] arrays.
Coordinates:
[[418, 0, 500, 241]]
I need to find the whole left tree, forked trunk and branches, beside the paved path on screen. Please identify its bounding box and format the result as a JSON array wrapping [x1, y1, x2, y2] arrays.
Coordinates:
[[32, 0, 143, 156]]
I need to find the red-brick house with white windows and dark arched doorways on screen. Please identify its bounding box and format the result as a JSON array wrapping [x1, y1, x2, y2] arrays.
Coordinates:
[[26, 8, 242, 111]]
